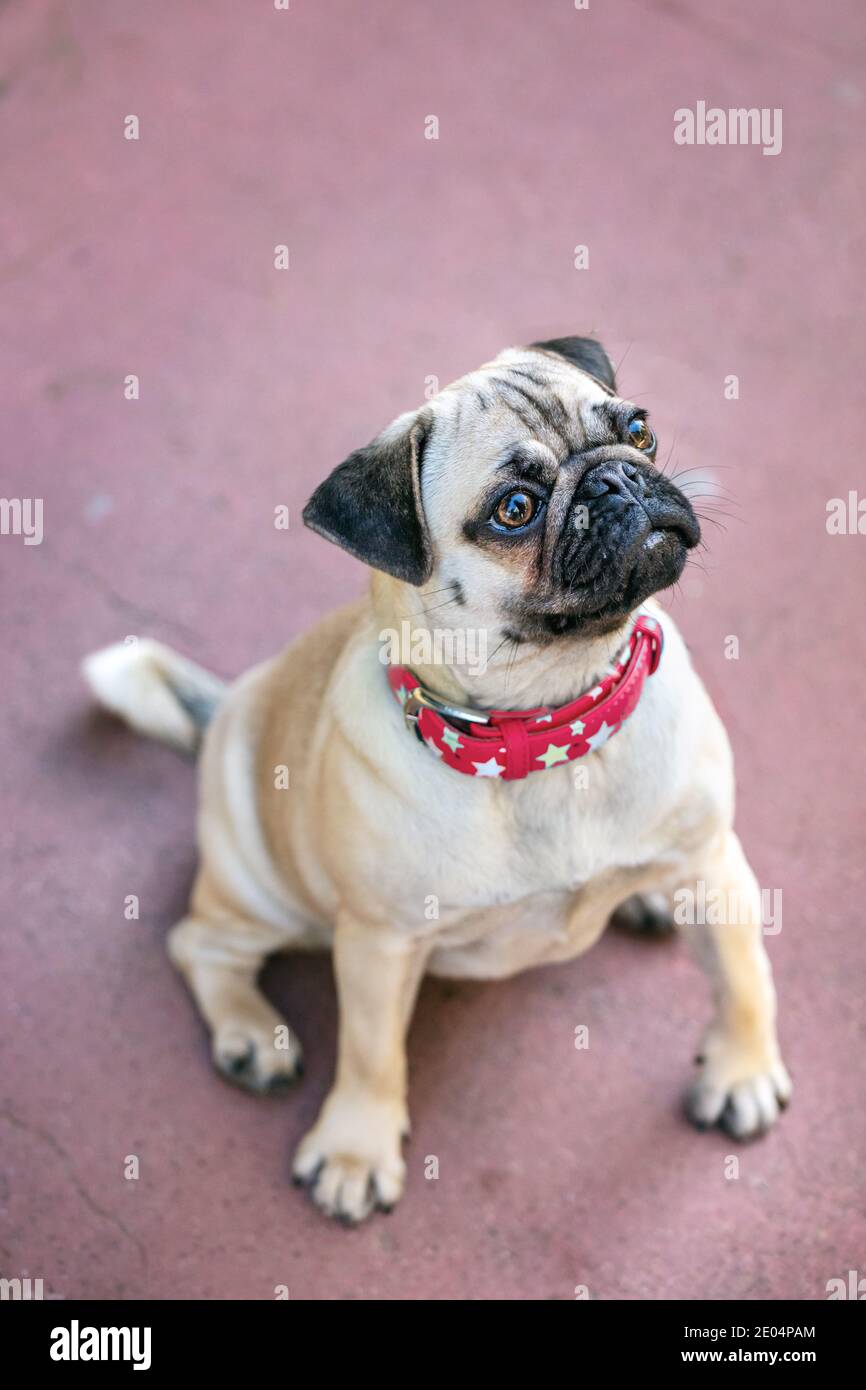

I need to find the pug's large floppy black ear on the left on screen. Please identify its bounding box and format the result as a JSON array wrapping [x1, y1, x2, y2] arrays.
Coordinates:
[[303, 413, 432, 584]]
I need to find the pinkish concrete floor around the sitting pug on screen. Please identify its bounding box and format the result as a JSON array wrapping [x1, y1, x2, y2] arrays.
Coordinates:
[[0, 0, 866, 1300]]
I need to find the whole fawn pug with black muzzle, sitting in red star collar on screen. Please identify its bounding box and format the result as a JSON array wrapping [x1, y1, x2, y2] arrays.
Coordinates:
[[83, 338, 791, 1223]]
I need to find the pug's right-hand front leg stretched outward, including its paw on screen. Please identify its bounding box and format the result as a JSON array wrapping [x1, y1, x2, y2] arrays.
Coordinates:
[[674, 831, 791, 1138]]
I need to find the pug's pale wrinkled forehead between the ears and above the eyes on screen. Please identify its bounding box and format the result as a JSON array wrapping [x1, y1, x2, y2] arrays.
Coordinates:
[[423, 348, 621, 499]]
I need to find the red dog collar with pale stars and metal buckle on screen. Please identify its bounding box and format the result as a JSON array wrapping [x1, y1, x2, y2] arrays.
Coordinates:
[[388, 616, 663, 781]]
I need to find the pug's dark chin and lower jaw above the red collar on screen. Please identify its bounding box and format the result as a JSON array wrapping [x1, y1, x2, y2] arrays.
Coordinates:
[[507, 528, 691, 644]]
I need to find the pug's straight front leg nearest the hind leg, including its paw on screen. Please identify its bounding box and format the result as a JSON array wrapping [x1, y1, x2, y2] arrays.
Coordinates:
[[293, 915, 428, 1222]]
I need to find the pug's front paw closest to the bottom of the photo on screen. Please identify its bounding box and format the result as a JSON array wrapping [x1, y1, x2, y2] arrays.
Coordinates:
[[292, 1091, 409, 1226]]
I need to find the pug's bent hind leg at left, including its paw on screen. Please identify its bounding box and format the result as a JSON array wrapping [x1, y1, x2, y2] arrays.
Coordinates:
[[168, 916, 302, 1095]]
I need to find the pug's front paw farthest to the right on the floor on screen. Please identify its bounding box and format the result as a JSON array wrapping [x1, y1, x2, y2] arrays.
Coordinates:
[[685, 1040, 792, 1138]]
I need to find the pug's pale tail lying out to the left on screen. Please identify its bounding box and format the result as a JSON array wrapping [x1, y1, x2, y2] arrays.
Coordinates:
[[81, 638, 225, 752]]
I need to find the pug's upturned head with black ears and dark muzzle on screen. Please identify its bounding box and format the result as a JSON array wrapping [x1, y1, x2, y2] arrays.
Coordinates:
[[304, 338, 701, 642]]
